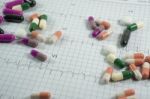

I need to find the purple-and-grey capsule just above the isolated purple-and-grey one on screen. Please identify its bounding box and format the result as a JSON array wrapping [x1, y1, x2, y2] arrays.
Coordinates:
[[19, 38, 38, 48]]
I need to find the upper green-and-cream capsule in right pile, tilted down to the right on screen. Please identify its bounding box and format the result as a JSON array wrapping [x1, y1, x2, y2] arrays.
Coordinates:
[[106, 54, 126, 69]]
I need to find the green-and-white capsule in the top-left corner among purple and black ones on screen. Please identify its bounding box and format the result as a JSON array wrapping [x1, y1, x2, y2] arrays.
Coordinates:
[[12, 3, 30, 11]]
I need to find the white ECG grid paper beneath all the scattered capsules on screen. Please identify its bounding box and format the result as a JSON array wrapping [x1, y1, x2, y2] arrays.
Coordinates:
[[0, 0, 150, 99]]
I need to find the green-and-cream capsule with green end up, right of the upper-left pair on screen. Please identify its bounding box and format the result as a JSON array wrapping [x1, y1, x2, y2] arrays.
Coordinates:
[[39, 14, 47, 29]]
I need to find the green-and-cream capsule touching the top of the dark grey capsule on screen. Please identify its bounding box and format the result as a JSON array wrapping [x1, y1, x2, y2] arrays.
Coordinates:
[[127, 22, 144, 31]]
